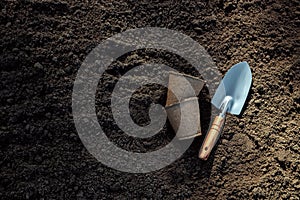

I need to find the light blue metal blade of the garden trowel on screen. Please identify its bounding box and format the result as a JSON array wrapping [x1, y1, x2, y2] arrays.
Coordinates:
[[212, 62, 252, 115]]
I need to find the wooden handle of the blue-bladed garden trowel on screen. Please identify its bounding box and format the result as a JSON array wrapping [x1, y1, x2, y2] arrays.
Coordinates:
[[199, 115, 225, 160]]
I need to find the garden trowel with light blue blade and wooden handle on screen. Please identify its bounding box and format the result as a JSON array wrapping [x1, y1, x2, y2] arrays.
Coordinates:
[[199, 62, 252, 160]]
